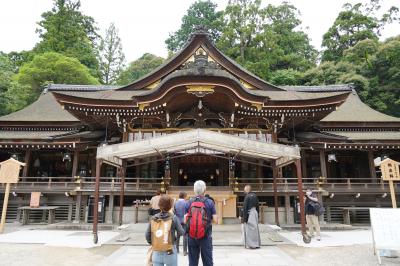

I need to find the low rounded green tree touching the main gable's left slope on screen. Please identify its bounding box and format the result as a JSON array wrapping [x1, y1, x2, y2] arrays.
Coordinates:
[[118, 53, 164, 85]]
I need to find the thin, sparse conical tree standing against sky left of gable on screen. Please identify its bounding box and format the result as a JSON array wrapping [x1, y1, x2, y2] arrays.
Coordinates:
[[99, 23, 125, 84]]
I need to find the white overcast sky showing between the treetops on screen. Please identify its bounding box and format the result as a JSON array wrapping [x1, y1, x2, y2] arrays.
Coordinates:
[[0, 0, 400, 62]]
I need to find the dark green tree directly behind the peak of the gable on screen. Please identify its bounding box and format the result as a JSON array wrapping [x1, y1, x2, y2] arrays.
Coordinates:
[[165, 0, 222, 52]]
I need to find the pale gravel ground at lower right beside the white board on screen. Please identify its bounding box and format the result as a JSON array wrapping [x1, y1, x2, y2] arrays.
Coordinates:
[[279, 245, 400, 266]]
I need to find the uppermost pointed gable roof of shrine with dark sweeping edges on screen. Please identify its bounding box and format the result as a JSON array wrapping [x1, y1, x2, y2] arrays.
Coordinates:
[[117, 31, 284, 91]]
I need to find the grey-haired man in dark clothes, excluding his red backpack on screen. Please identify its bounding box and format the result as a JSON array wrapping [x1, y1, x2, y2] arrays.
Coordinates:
[[185, 180, 217, 266]]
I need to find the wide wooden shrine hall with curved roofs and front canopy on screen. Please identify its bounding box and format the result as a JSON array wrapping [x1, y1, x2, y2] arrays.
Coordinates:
[[0, 31, 400, 241]]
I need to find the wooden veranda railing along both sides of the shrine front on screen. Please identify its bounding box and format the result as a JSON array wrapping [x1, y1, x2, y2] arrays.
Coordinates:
[[0, 177, 400, 192]]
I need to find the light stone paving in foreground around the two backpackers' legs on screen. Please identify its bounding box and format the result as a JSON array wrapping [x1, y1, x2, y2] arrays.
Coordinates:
[[100, 246, 298, 266]]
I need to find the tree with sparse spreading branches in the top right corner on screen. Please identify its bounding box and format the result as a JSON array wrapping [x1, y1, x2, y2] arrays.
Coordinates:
[[322, 0, 399, 61]]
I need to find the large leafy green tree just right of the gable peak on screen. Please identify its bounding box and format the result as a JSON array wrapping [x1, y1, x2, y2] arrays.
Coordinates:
[[217, 0, 317, 80]]
